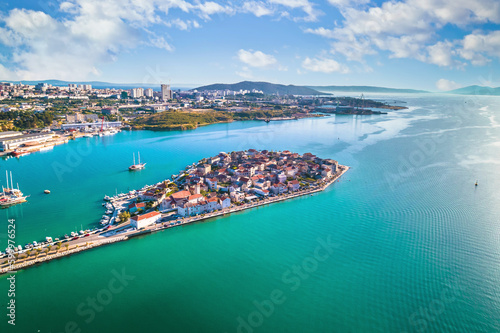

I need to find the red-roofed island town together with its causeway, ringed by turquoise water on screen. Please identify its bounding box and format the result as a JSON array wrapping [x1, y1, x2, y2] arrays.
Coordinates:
[[0, 149, 349, 274]]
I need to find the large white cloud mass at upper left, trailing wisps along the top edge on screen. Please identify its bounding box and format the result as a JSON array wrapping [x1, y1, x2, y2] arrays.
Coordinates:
[[0, 0, 240, 80]]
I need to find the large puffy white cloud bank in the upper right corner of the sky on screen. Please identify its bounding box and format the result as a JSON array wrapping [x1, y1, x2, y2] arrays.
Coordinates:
[[322, 0, 500, 67]]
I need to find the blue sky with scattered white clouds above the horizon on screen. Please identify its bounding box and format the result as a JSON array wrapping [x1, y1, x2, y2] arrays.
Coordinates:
[[0, 0, 500, 91]]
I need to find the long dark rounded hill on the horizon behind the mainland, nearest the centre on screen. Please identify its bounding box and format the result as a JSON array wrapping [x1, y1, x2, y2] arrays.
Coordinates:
[[196, 81, 329, 95]]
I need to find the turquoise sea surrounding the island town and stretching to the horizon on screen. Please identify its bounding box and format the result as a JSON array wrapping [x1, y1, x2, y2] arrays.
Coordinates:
[[0, 94, 500, 333]]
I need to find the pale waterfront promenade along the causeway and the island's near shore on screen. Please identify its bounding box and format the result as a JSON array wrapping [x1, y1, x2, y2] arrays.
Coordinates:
[[0, 165, 350, 275]]
